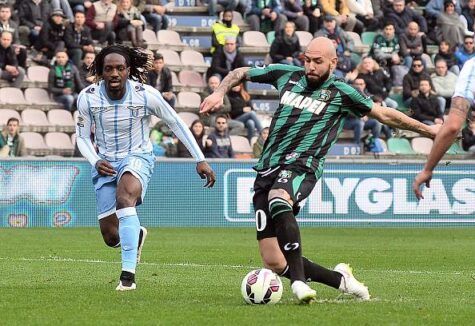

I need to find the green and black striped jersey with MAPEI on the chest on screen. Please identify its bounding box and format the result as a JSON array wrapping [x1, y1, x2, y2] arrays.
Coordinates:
[[248, 64, 373, 171]]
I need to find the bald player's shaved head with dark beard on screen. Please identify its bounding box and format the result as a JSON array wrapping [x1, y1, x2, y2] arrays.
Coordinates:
[[304, 37, 338, 87]]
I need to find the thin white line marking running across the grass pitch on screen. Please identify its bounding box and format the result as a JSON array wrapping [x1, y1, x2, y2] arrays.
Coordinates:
[[0, 256, 472, 275]]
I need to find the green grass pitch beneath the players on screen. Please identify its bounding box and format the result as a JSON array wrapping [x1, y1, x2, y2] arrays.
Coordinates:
[[0, 228, 475, 325]]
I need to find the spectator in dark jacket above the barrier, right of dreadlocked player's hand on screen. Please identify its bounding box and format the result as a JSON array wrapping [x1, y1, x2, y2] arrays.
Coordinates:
[[205, 114, 234, 158]]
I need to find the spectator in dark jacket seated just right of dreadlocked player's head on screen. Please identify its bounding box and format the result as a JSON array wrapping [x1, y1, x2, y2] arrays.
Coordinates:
[[148, 53, 176, 108]]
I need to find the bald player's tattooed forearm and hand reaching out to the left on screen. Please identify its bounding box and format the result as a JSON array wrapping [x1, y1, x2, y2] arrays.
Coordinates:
[[200, 67, 250, 114]]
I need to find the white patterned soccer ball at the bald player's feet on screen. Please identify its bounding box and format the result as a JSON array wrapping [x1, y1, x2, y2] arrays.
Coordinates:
[[241, 268, 284, 304]]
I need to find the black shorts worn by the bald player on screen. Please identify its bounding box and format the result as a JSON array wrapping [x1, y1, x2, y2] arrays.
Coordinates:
[[252, 165, 321, 240]]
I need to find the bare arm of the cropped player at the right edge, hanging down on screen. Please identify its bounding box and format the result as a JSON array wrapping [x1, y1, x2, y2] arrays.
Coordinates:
[[412, 97, 470, 199]]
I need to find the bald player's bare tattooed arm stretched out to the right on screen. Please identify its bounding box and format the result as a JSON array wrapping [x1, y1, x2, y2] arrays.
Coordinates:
[[368, 104, 440, 138]]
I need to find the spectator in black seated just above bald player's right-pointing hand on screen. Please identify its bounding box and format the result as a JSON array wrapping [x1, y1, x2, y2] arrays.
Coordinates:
[[410, 79, 444, 125]]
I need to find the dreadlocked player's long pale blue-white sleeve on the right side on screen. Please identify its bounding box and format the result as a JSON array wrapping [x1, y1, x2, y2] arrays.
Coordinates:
[[145, 87, 205, 162]]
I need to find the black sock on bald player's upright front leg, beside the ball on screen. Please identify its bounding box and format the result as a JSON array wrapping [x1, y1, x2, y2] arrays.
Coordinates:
[[269, 198, 305, 283]]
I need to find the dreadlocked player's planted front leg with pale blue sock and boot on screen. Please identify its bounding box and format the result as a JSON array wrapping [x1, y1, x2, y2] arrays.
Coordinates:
[[116, 172, 142, 291]]
